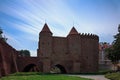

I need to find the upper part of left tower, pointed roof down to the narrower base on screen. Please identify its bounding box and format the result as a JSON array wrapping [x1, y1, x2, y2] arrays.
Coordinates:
[[38, 23, 52, 57]]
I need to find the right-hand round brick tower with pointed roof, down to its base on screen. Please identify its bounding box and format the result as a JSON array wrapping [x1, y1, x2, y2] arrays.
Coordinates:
[[67, 27, 81, 73]]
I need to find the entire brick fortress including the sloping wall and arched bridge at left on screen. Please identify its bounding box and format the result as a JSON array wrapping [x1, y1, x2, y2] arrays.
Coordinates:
[[0, 23, 99, 77]]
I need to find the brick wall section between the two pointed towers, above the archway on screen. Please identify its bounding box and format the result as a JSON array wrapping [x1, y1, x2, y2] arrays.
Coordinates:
[[51, 37, 68, 61]]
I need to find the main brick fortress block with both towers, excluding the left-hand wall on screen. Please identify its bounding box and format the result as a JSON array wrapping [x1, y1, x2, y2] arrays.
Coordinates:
[[37, 23, 99, 73]]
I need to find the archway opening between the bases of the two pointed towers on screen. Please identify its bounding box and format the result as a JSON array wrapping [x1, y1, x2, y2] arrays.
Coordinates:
[[51, 64, 67, 74]]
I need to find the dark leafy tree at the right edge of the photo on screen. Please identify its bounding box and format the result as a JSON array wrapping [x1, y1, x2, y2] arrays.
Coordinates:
[[106, 25, 120, 70]]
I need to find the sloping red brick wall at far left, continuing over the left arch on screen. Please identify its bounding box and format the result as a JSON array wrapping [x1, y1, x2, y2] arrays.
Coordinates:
[[0, 40, 39, 77]]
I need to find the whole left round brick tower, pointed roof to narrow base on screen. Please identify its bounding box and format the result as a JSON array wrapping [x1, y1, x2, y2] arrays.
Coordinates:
[[37, 23, 52, 72]]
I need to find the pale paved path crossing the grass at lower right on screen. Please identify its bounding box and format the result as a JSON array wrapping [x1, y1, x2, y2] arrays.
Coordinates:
[[71, 75, 109, 80]]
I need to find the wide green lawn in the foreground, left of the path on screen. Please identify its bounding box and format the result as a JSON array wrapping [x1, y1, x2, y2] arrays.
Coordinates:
[[0, 72, 92, 80]]
